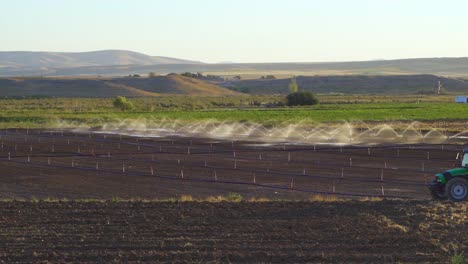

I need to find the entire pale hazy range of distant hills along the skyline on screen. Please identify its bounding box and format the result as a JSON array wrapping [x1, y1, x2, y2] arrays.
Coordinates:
[[0, 50, 468, 77]]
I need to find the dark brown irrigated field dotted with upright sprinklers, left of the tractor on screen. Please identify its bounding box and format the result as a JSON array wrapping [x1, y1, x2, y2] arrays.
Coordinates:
[[0, 129, 464, 199]]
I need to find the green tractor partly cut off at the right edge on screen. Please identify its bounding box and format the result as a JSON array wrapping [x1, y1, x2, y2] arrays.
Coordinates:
[[429, 148, 468, 202]]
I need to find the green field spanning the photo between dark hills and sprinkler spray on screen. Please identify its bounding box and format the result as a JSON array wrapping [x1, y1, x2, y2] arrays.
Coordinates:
[[0, 96, 468, 128]]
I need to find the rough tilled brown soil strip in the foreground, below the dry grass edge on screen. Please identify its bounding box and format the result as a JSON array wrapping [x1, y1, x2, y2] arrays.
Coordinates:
[[0, 200, 468, 263]]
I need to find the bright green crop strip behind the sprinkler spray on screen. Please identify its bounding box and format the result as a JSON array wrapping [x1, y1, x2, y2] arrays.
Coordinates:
[[0, 99, 468, 131]]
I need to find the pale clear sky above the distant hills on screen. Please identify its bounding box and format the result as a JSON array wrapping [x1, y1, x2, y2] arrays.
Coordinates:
[[0, 0, 468, 63]]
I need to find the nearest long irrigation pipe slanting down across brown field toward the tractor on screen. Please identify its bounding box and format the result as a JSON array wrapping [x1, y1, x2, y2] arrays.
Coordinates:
[[0, 159, 420, 199]]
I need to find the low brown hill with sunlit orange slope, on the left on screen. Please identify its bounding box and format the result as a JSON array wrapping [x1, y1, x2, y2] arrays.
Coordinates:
[[0, 74, 237, 97]]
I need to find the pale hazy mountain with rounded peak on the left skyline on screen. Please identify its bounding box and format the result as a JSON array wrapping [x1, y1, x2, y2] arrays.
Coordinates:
[[0, 50, 200, 70]]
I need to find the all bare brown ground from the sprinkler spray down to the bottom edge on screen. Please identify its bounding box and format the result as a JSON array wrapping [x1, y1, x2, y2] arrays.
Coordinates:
[[0, 129, 468, 263]]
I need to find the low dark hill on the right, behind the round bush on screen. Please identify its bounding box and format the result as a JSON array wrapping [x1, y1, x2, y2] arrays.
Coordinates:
[[223, 75, 468, 94]]
